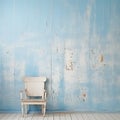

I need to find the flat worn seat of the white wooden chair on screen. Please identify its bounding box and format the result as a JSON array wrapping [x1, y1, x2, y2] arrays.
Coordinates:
[[21, 99, 46, 105]]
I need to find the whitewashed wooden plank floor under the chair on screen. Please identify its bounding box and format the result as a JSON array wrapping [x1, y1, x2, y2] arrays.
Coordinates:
[[0, 113, 120, 120]]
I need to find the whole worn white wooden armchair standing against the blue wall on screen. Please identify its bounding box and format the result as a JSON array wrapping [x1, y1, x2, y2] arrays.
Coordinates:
[[20, 77, 46, 116]]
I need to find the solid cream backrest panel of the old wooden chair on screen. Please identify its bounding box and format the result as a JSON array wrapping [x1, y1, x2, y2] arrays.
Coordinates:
[[23, 77, 46, 97]]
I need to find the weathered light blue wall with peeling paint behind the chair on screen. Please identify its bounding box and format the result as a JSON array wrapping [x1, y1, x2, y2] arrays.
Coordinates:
[[0, 0, 120, 112]]
